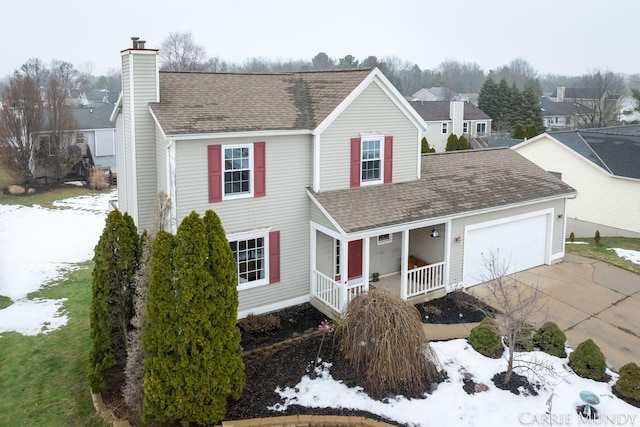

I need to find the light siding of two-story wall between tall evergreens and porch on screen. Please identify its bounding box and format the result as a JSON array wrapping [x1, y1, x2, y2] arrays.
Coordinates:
[[175, 136, 311, 313]]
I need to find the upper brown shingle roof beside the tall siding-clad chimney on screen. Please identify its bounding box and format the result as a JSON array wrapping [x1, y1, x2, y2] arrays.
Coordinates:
[[151, 69, 371, 135]]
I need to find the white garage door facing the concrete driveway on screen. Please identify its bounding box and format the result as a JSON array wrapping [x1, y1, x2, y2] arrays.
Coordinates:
[[463, 214, 548, 287]]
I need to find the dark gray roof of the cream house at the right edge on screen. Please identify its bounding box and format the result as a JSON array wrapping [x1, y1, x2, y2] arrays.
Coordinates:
[[549, 125, 640, 179]]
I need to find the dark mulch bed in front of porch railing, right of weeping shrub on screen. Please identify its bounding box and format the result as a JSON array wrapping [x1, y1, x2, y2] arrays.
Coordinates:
[[416, 291, 496, 324]]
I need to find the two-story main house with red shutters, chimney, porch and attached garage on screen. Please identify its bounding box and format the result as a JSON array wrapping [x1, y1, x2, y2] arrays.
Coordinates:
[[112, 41, 575, 317]]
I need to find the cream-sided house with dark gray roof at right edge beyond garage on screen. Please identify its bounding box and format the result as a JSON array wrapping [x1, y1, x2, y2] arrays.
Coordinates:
[[500, 125, 640, 238]]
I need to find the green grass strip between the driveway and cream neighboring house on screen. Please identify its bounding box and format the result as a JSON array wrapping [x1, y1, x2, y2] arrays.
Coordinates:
[[565, 237, 640, 274]]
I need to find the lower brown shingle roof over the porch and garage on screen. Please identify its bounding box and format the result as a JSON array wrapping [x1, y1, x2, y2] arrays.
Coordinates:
[[312, 148, 575, 233]]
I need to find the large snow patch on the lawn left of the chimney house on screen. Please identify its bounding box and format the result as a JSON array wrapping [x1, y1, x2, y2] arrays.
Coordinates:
[[0, 193, 114, 335]]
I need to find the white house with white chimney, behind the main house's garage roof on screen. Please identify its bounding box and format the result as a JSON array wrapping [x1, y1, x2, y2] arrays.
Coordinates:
[[410, 101, 491, 152]]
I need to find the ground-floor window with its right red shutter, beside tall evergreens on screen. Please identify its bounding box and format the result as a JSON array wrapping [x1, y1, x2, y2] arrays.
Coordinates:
[[228, 230, 280, 289]]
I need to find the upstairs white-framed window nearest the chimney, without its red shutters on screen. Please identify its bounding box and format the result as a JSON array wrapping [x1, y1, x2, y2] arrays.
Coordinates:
[[223, 145, 253, 197]]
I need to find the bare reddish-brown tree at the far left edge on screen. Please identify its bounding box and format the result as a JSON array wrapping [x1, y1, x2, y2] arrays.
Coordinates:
[[0, 72, 43, 184]]
